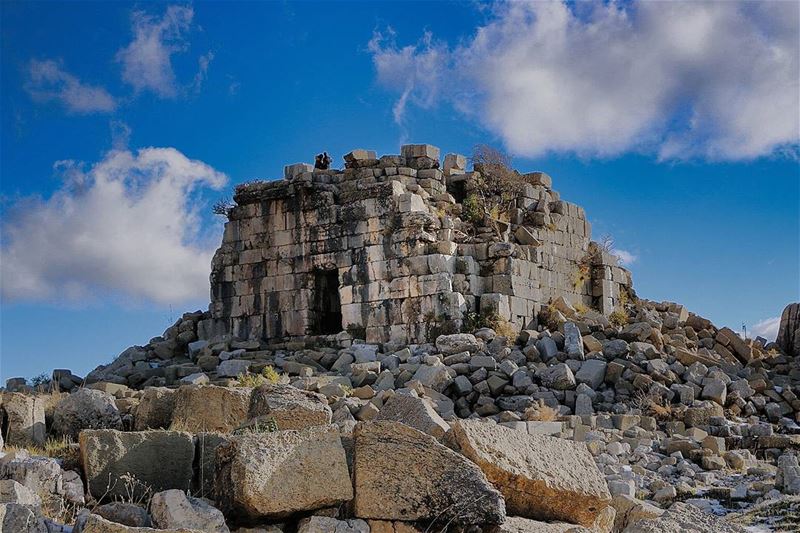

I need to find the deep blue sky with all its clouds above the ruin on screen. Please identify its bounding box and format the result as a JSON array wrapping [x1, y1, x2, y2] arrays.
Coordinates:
[[0, 2, 800, 379]]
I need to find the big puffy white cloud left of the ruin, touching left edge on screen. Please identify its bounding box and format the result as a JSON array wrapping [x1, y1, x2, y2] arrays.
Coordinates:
[[0, 148, 227, 303]]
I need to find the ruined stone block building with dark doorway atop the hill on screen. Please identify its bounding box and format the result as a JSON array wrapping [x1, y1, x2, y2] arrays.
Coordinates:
[[204, 144, 631, 343]]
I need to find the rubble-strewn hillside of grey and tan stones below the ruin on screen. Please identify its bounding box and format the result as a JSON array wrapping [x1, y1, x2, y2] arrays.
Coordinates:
[[0, 300, 800, 533]]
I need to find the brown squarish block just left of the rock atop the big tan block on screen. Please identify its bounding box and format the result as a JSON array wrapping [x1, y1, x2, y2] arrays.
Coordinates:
[[171, 385, 252, 433]]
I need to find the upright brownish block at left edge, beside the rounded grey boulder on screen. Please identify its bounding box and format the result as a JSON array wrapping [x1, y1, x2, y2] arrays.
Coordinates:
[[0, 392, 47, 446]]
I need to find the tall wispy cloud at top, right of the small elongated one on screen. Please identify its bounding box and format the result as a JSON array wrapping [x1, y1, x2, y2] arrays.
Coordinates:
[[117, 5, 202, 98]]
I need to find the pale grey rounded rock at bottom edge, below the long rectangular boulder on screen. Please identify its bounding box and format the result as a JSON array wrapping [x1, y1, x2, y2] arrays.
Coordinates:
[[150, 489, 230, 533]]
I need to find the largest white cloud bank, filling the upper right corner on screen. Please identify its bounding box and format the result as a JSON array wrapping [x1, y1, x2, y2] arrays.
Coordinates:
[[369, 0, 800, 160]]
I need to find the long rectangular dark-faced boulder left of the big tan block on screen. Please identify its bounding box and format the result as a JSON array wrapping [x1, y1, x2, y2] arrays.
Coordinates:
[[79, 429, 195, 498]]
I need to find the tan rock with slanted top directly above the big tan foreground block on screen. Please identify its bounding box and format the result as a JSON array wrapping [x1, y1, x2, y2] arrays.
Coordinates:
[[248, 385, 332, 430]]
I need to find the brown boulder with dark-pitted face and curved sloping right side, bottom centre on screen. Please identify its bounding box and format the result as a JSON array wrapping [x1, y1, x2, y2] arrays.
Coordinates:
[[353, 421, 505, 527]]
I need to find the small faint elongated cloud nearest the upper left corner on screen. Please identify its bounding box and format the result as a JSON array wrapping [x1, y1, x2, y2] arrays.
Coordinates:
[[25, 59, 117, 114]]
